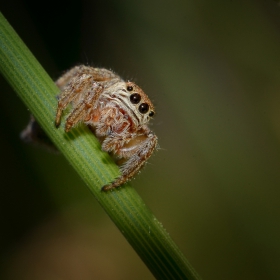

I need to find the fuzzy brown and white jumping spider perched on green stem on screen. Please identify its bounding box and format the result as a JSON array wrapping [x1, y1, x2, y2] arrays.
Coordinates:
[[55, 65, 157, 191]]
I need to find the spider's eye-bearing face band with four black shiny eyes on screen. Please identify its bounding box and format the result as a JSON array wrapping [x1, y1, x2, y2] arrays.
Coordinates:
[[126, 82, 155, 124]]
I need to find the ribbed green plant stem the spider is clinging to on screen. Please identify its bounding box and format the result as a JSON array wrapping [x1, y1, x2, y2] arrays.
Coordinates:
[[0, 13, 200, 279]]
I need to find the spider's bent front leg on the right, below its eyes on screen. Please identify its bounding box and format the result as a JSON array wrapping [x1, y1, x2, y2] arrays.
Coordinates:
[[102, 130, 157, 191]]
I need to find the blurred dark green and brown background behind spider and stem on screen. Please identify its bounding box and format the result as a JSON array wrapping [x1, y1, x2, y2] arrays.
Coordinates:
[[0, 0, 280, 280]]
